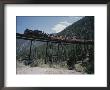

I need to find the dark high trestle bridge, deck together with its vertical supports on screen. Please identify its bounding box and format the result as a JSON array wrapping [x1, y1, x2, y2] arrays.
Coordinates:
[[16, 33, 94, 63]]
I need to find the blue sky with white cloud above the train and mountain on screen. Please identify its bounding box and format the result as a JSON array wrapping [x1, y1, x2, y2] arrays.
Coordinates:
[[16, 16, 83, 34]]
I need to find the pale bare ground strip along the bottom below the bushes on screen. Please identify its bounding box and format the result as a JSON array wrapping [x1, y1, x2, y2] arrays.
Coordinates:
[[17, 63, 82, 74]]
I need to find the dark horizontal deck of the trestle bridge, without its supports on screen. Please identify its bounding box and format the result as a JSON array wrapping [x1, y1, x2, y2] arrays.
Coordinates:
[[16, 33, 94, 44]]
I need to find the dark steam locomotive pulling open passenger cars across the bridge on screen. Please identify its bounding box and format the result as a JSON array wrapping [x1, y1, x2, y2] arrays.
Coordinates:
[[24, 29, 77, 40]]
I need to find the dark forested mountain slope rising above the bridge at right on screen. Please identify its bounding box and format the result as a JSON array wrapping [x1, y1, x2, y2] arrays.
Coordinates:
[[58, 16, 94, 40]]
